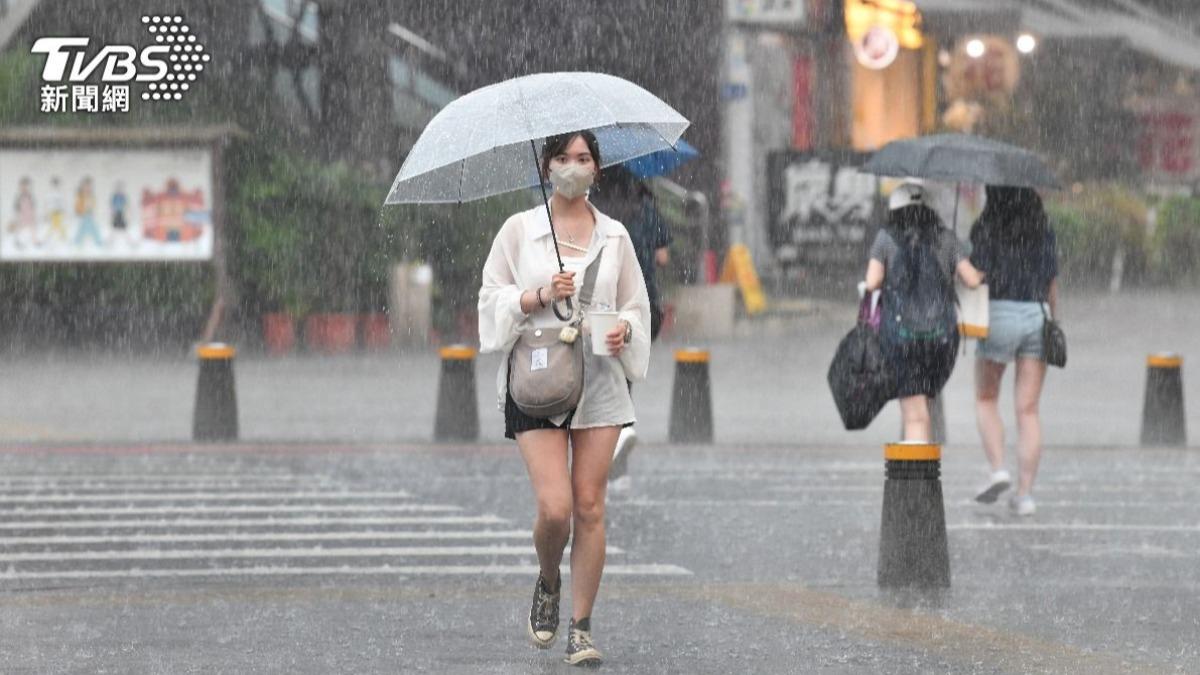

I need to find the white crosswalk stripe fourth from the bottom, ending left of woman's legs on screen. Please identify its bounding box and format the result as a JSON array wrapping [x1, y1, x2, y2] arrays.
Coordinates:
[[0, 515, 508, 531]]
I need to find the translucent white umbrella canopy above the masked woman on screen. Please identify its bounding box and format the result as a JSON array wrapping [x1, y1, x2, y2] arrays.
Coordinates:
[[386, 72, 689, 204]]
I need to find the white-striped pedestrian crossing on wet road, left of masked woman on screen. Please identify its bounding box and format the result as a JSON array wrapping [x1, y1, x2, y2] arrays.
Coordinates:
[[0, 473, 691, 584]]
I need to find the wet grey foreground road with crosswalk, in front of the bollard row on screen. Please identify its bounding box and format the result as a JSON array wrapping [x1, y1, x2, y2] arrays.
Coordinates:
[[0, 444, 1200, 673]]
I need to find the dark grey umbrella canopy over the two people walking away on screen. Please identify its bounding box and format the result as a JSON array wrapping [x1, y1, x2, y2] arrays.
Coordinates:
[[863, 133, 1058, 187]]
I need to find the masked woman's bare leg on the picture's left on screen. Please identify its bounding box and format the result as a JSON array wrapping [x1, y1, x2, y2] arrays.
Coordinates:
[[517, 429, 572, 589]]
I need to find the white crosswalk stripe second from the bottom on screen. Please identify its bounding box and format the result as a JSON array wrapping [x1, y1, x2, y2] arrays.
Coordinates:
[[0, 544, 625, 562]]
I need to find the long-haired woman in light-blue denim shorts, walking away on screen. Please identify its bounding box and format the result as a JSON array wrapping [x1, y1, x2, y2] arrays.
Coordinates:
[[971, 185, 1058, 515]]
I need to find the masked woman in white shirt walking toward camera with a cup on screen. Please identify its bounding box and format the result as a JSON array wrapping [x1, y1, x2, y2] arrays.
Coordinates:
[[479, 131, 650, 665]]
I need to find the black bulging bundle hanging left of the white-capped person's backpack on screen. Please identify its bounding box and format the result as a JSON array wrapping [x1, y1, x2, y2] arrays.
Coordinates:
[[827, 321, 896, 431]]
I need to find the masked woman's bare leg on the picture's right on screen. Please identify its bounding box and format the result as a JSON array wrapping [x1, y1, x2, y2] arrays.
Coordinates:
[[571, 426, 620, 620]]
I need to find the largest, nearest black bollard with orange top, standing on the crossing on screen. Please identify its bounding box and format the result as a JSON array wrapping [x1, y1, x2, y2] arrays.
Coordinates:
[[878, 442, 950, 589]]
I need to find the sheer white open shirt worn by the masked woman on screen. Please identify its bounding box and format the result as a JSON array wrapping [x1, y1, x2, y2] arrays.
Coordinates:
[[479, 203, 650, 429]]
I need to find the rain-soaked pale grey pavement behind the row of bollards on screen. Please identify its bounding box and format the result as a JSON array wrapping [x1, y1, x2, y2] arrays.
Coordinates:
[[0, 292, 1200, 447]]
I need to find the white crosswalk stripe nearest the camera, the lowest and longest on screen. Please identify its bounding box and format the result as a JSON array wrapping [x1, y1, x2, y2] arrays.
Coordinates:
[[0, 565, 692, 581]]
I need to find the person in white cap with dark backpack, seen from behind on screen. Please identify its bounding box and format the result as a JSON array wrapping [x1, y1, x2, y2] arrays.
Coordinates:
[[865, 183, 983, 441]]
